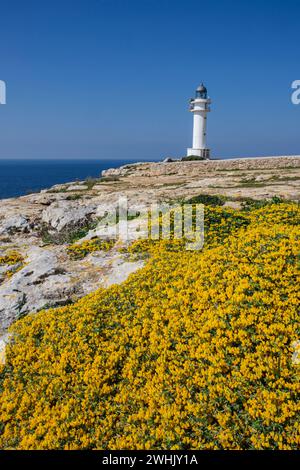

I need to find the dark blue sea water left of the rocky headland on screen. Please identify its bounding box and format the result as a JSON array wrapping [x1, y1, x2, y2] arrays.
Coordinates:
[[0, 160, 140, 199]]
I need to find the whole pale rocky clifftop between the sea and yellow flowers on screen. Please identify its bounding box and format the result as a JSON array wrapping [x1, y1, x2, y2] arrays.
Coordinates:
[[0, 157, 300, 349]]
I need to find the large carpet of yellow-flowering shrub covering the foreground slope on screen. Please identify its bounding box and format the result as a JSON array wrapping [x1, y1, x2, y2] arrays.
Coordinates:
[[0, 204, 300, 450]]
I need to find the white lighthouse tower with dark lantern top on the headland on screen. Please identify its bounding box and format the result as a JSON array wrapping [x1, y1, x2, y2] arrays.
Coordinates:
[[187, 83, 211, 158]]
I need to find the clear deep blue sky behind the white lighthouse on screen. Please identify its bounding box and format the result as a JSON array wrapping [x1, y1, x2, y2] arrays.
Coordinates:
[[0, 0, 300, 160]]
